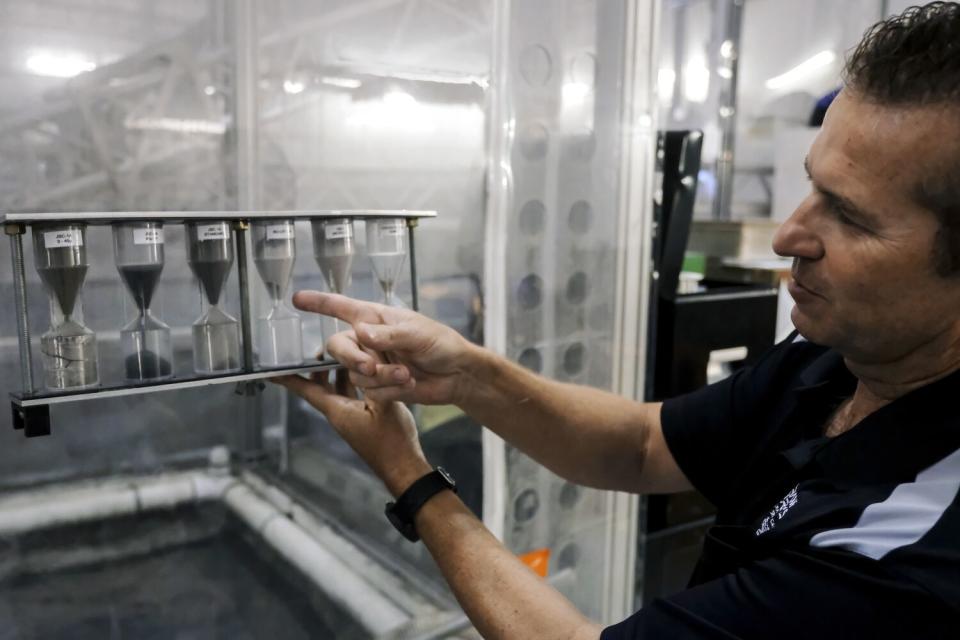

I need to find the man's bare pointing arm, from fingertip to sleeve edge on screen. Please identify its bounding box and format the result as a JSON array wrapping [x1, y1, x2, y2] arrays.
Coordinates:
[[294, 291, 691, 493]]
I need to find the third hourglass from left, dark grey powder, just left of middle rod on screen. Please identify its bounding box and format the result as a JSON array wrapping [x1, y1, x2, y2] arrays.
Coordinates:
[[186, 221, 241, 374]]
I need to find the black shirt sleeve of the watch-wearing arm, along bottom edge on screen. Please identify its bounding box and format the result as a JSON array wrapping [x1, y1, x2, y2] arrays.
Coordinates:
[[600, 553, 960, 640]]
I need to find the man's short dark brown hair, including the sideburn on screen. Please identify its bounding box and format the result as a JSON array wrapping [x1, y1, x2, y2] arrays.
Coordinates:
[[843, 2, 960, 276]]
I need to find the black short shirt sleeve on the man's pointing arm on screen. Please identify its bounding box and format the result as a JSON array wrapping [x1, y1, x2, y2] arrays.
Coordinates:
[[660, 335, 806, 508]]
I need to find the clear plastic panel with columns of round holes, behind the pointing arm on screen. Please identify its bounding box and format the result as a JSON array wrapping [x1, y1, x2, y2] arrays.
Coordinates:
[[485, 0, 656, 621]]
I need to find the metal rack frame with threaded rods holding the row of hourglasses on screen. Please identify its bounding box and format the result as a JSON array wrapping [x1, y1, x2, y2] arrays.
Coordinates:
[[0, 209, 437, 437]]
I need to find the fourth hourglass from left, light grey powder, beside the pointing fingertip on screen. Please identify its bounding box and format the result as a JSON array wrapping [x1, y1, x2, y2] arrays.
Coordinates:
[[251, 220, 303, 367]]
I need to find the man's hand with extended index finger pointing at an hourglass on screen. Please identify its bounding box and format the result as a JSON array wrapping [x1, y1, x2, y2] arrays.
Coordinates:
[[293, 291, 475, 404]]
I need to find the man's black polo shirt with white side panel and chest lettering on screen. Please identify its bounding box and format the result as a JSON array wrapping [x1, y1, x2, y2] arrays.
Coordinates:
[[601, 334, 960, 640]]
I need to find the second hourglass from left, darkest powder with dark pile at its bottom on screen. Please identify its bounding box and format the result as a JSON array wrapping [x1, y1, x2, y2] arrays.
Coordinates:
[[113, 222, 173, 382]]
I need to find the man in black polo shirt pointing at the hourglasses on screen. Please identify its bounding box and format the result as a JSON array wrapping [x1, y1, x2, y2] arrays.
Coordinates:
[[283, 3, 960, 640]]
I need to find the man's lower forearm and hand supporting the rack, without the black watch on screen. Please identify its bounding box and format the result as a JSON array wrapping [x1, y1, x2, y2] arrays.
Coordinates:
[[276, 376, 600, 640]]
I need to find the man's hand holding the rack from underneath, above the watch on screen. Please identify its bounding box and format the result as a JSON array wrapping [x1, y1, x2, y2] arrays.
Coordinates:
[[273, 371, 431, 496]]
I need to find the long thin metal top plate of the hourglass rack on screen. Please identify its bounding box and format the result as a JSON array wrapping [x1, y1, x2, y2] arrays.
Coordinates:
[[0, 209, 437, 224]]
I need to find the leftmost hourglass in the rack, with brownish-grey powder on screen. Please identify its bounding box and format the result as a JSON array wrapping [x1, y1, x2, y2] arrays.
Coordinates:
[[33, 223, 100, 389]]
